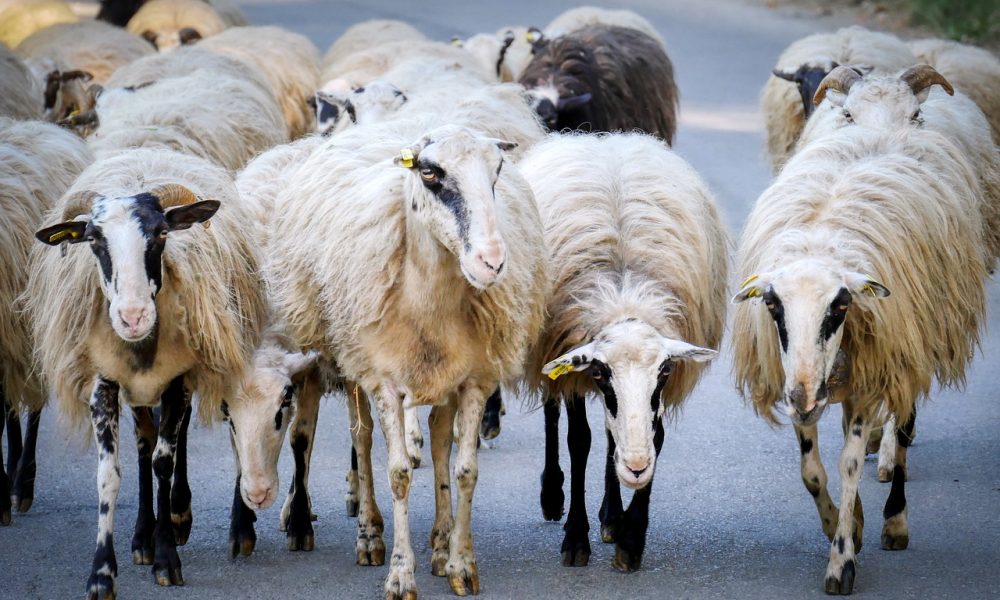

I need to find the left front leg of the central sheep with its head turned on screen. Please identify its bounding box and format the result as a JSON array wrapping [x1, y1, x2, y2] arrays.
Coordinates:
[[374, 386, 417, 600]]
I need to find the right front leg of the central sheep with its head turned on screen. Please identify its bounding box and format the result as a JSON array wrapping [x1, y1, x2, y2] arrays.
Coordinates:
[[444, 385, 487, 596]]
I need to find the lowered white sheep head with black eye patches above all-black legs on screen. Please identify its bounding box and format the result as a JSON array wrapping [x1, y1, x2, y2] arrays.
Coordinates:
[[542, 318, 717, 489]]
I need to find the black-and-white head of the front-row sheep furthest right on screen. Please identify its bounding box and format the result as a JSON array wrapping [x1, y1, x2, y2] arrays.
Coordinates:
[[733, 258, 889, 424]]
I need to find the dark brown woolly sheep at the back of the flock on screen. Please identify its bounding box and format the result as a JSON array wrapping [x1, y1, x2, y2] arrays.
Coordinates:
[[520, 25, 678, 144]]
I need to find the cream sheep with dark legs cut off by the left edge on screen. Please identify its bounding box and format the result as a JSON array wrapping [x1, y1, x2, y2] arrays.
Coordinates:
[[0, 117, 92, 525]]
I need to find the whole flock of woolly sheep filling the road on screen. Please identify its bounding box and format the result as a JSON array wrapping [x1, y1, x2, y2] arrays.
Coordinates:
[[0, 0, 1000, 599]]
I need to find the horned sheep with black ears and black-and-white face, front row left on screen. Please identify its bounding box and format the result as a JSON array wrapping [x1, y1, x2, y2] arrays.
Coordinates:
[[26, 148, 266, 598]]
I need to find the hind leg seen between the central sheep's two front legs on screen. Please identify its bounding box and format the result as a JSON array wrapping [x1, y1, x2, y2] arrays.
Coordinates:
[[427, 401, 455, 577]]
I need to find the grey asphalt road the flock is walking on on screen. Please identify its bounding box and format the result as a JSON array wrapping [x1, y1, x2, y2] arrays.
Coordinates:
[[0, 0, 1000, 600]]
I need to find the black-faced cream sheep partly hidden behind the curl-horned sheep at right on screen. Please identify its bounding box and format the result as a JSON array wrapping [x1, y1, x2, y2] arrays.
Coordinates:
[[760, 25, 917, 173]]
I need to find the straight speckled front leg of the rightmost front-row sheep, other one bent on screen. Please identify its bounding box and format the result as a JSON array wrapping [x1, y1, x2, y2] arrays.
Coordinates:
[[824, 402, 871, 595]]
